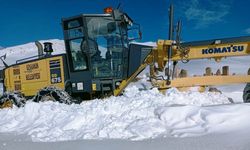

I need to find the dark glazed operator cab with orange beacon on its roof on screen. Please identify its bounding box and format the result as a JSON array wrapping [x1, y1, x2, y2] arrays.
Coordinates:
[[62, 8, 138, 98]]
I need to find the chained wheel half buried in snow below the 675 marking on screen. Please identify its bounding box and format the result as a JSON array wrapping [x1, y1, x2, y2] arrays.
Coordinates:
[[33, 86, 72, 104]]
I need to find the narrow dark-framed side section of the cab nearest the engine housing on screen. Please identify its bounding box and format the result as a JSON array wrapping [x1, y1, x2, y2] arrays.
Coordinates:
[[63, 16, 91, 93]]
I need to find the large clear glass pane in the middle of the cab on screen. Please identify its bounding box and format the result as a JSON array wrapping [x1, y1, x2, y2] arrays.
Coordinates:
[[86, 16, 123, 77]]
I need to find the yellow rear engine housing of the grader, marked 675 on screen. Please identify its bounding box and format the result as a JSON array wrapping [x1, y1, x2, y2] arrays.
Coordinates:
[[4, 56, 64, 96]]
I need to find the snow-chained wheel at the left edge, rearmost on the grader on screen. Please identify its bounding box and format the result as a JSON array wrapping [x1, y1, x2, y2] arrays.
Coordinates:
[[0, 92, 26, 108]]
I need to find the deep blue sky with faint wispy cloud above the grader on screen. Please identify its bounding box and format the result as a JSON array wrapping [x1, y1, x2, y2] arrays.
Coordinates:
[[0, 0, 250, 47]]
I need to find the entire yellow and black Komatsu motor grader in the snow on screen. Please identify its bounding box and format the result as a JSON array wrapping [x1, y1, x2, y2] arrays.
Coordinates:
[[0, 6, 250, 107]]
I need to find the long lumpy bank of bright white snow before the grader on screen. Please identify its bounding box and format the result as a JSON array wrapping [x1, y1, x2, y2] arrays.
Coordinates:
[[0, 86, 244, 142]]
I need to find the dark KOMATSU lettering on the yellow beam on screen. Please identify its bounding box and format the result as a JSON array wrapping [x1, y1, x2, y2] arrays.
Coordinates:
[[202, 45, 244, 54]]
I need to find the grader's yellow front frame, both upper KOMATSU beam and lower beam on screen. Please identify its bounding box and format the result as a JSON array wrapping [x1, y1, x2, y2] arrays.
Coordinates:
[[151, 37, 250, 89]]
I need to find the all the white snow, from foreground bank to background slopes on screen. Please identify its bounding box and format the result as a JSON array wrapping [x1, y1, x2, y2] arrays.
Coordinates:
[[0, 40, 250, 150]]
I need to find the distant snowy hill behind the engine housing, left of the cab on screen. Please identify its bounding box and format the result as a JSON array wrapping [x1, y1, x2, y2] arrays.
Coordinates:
[[0, 39, 65, 66]]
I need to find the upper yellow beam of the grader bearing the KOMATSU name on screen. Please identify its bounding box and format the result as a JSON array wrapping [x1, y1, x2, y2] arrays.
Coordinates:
[[154, 40, 250, 63]]
